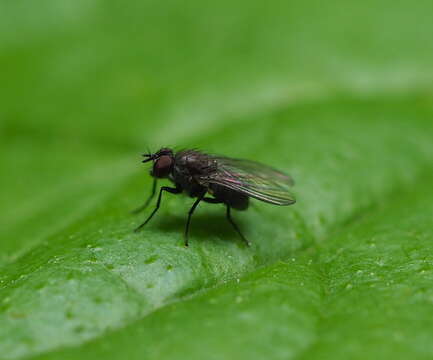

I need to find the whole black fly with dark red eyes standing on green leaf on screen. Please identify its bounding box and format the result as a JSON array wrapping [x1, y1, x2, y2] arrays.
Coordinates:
[[134, 148, 295, 246]]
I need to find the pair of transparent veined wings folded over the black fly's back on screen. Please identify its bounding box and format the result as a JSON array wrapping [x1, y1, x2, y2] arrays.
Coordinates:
[[199, 156, 296, 205]]
